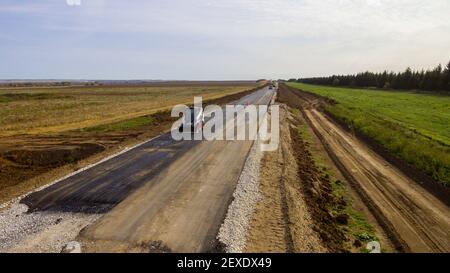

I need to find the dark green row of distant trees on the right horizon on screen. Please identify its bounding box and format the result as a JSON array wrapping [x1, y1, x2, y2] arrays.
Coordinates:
[[289, 62, 450, 94]]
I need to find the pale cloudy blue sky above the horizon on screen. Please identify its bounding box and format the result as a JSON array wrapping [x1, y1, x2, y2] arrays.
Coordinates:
[[0, 0, 450, 80]]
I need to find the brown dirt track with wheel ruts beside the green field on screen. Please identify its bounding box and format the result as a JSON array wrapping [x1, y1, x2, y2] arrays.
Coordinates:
[[282, 84, 450, 252]]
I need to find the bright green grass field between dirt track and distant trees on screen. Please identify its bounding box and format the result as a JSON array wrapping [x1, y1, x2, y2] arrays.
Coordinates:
[[288, 83, 450, 186]]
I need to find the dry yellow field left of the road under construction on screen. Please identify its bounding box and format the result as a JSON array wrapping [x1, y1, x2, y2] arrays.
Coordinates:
[[0, 82, 256, 136]]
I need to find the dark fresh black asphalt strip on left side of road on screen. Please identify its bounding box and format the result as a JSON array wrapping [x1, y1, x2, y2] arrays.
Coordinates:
[[21, 134, 199, 213]]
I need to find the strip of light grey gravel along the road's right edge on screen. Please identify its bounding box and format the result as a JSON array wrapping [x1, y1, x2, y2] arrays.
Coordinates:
[[217, 141, 263, 253]]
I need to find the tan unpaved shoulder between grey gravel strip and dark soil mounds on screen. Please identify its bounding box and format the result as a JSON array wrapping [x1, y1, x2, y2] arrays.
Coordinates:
[[246, 107, 326, 252]]
